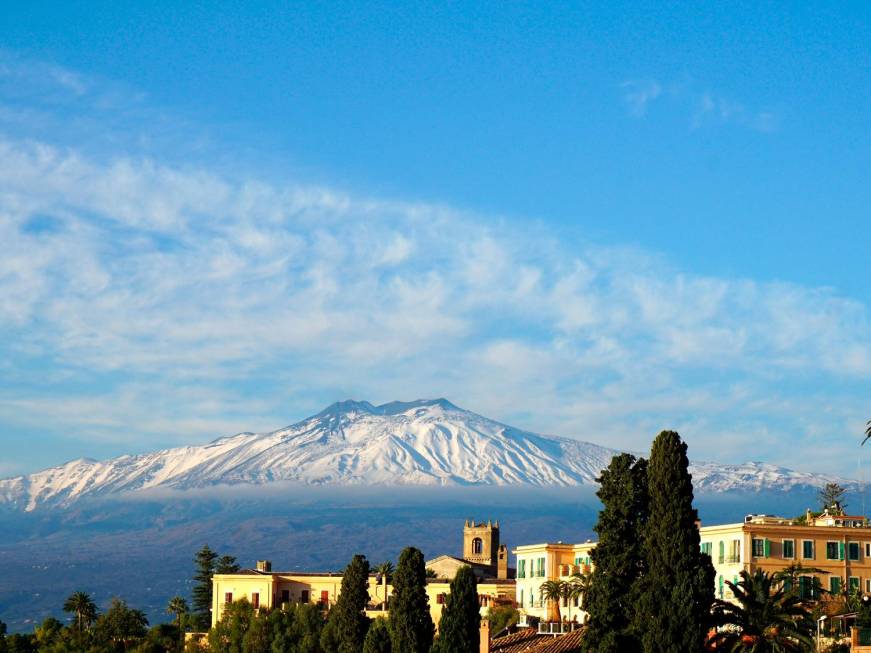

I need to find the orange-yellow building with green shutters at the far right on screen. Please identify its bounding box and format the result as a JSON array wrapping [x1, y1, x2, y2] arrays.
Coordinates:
[[699, 510, 871, 599]]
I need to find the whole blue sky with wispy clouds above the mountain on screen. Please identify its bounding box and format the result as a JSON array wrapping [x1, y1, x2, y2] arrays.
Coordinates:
[[0, 2, 871, 475]]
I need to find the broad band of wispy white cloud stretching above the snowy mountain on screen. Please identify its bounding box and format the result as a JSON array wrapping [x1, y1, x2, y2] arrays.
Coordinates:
[[0, 56, 871, 471]]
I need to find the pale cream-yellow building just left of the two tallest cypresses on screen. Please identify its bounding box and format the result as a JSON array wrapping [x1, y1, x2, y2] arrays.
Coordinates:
[[512, 541, 596, 623]]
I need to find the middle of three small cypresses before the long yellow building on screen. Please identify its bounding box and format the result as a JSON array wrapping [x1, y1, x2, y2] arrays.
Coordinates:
[[389, 547, 435, 653]]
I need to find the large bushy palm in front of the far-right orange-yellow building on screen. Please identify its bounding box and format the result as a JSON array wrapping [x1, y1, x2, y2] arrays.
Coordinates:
[[708, 569, 813, 653]]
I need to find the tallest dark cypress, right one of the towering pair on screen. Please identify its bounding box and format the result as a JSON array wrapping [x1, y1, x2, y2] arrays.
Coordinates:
[[635, 431, 714, 653]]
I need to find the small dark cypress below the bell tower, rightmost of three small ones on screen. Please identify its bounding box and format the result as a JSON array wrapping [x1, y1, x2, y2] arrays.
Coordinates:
[[433, 567, 481, 653]]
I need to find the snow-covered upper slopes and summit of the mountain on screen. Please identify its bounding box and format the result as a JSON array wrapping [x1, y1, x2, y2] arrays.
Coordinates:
[[0, 399, 840, 511]]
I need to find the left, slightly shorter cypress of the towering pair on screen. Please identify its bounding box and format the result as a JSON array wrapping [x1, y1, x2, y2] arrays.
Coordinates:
[[582, 453, 648, 653]]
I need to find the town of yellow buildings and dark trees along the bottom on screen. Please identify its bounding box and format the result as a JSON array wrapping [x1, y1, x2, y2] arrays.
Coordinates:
[[6, 431, 871, 653]]
